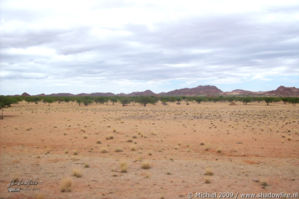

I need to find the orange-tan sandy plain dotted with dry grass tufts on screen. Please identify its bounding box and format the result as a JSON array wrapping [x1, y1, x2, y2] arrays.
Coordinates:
[[0, 102, 299, 199]]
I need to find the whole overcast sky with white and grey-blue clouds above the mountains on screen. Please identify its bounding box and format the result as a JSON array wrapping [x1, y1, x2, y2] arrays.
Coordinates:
[[0, 0, 299, 95]]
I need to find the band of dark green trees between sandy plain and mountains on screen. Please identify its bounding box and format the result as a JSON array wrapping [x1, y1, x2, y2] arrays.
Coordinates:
[[0, 96, 299, 108]]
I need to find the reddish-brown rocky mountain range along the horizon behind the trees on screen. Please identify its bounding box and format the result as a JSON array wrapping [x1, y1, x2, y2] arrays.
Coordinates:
[[22, 85, 299, 97]]
